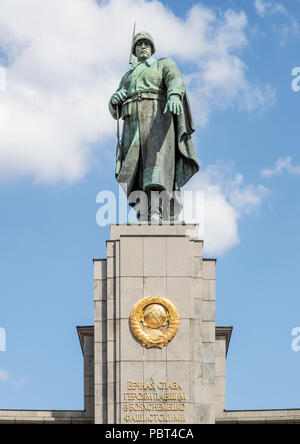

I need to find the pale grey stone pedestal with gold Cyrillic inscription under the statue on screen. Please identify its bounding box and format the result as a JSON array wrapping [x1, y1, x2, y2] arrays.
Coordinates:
[[94, 225, 216, 424]]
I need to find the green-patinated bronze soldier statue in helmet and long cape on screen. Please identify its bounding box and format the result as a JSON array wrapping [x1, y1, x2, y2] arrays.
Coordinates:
[[109, 32, 199, 222]]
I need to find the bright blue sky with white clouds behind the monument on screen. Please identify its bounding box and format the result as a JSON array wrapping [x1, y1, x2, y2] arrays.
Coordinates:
[[0, 0, 300, 409]]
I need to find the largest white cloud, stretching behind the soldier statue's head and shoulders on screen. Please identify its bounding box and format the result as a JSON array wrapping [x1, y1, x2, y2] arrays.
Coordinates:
[[0, 0, 274, 183]]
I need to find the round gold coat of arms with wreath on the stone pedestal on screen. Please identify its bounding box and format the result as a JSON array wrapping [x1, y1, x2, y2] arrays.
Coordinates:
[[130, 296, 179, 348]]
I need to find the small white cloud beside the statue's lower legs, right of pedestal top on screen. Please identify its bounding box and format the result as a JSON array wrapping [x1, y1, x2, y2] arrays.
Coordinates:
[[185, 162, 268, 255]]
